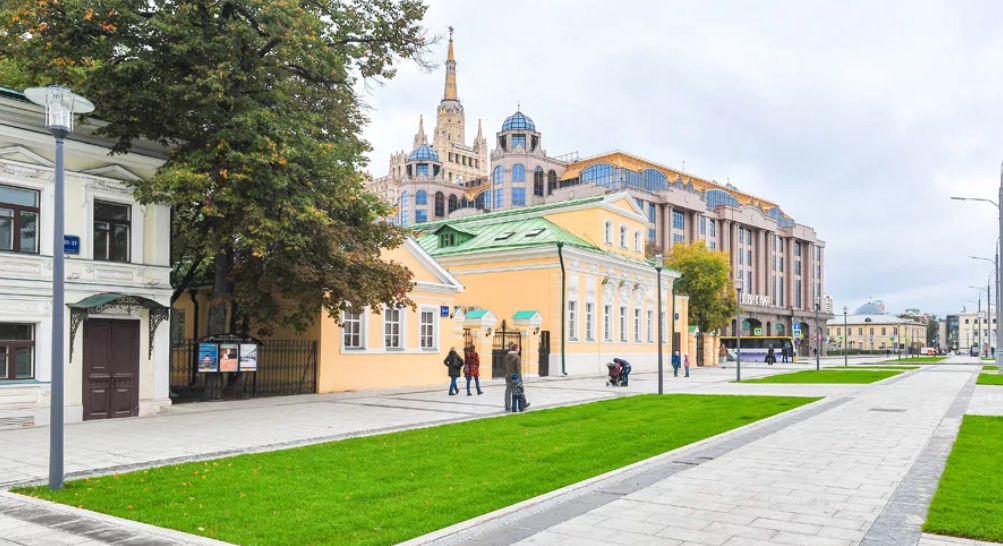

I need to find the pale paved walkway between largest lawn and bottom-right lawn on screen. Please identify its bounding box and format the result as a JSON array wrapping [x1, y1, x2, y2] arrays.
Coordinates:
[[441, 365, 976, 546]]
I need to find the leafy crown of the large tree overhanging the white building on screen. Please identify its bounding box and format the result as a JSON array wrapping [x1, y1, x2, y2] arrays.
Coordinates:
[[0, 0, 427, 333]]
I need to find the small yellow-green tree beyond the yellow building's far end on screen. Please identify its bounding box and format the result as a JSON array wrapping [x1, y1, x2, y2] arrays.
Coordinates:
[[666, 241, 738, 332]]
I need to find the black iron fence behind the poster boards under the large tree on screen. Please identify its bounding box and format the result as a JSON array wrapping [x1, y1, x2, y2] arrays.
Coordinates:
[[171, 339, 317, 403]]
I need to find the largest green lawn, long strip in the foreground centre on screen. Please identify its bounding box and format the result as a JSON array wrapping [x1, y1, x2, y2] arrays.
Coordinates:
[[17, 395, 814, 546]]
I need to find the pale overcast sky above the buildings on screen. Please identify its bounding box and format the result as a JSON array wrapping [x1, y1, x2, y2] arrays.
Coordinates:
[[365, 0, 1003, 315]]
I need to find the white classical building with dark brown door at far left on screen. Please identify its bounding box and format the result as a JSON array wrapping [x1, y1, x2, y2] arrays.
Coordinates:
[[0, 87, 172, 429]]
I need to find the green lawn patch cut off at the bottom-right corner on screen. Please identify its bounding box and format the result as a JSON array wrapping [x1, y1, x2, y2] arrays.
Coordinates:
[[923, 416, 1003, 542]]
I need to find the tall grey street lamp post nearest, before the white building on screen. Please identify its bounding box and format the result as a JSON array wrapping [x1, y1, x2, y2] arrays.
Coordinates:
[[24, 85, 94, 491]]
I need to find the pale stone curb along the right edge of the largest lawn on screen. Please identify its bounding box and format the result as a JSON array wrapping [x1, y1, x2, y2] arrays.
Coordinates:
[[397, 394, 841, 546]]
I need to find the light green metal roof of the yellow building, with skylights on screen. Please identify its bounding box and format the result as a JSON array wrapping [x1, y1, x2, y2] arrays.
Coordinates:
[[417, 213, 599, 257]]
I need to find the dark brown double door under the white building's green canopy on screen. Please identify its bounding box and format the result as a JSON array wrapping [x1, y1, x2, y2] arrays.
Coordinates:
[[83, 318, 139, 421]]
